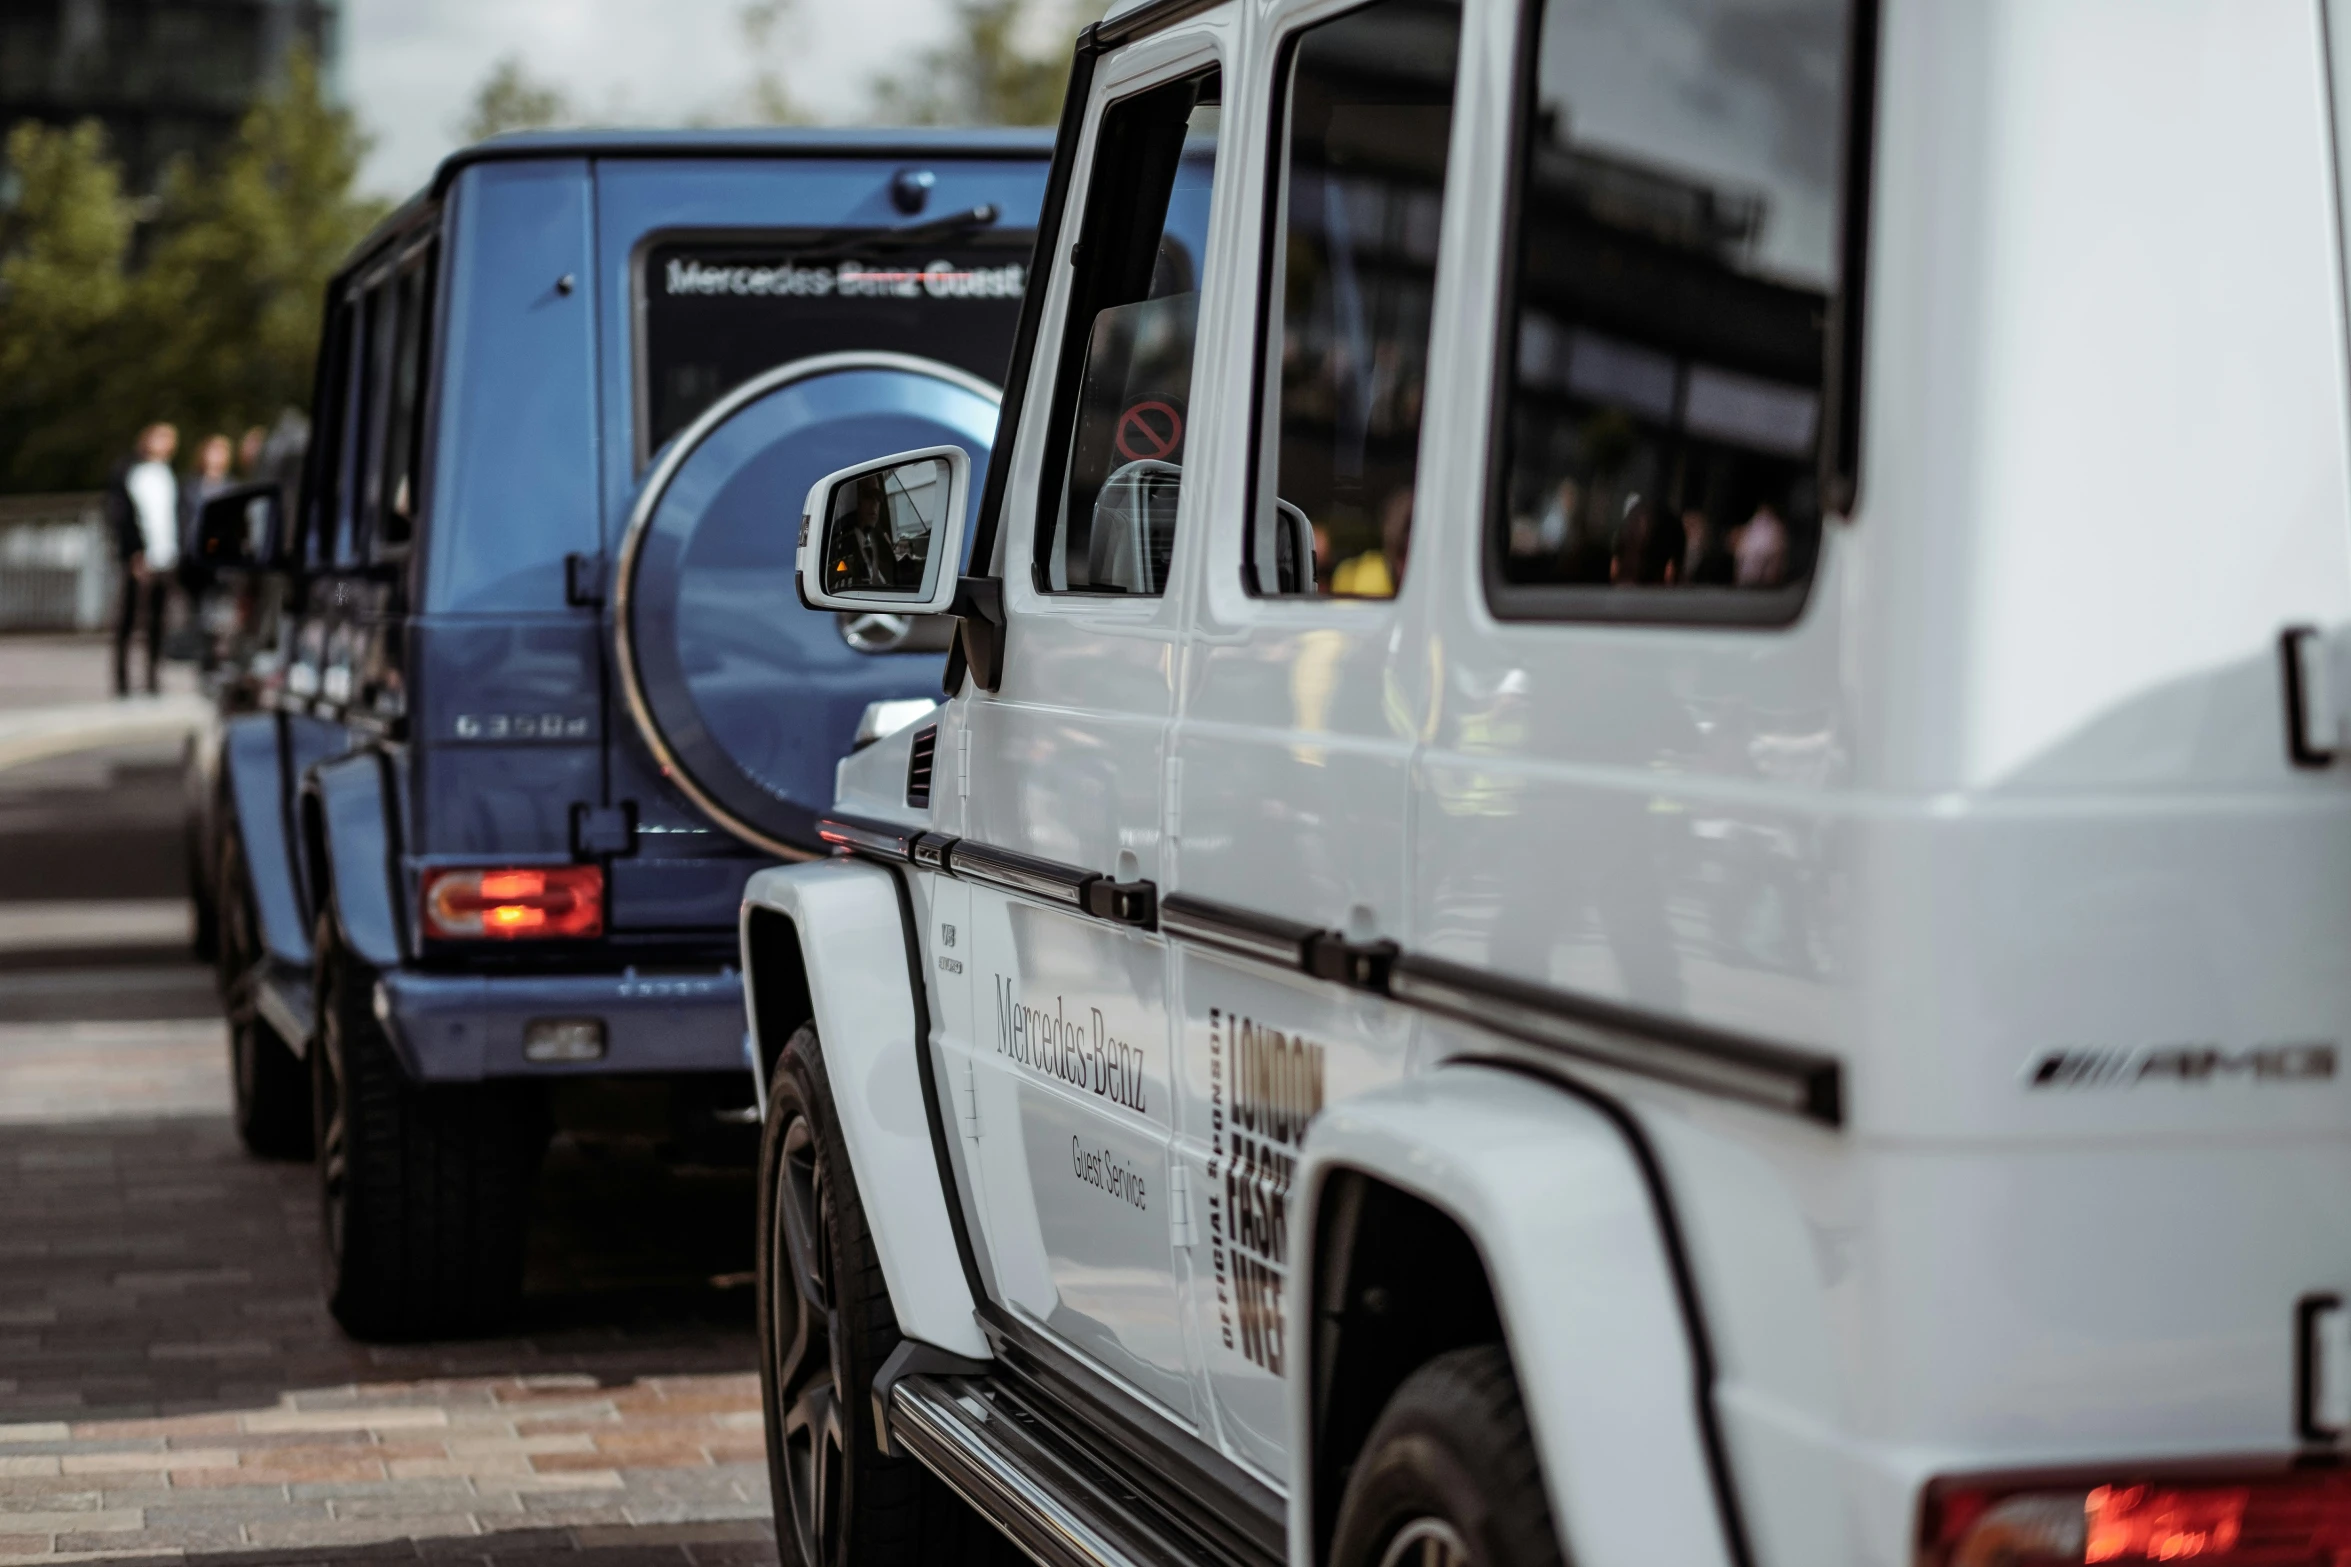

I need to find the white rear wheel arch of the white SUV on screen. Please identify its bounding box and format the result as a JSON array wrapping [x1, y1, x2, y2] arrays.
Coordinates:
[[1288, 1064, 1747, 1567]]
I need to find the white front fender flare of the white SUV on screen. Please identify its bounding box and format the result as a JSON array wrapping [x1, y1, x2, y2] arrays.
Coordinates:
[[743, 860, 990, 1360]]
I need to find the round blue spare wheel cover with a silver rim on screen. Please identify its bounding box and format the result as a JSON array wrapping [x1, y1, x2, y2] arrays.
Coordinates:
[[614, 352, 997, 858]]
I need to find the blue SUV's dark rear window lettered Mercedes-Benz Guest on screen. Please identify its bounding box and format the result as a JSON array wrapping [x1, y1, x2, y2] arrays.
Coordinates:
[[637, 230, 1030, 463]]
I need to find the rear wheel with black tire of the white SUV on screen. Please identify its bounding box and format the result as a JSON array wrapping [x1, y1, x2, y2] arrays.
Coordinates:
[[1331, 1344, 1563, 1567]]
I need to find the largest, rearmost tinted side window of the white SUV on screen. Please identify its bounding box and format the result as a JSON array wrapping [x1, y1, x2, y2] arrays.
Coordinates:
[[1488, 0, 1853, 620]]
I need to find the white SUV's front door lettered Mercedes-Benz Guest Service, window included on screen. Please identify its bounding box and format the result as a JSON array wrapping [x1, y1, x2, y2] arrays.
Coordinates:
[[938, 27, 1230, 1426]]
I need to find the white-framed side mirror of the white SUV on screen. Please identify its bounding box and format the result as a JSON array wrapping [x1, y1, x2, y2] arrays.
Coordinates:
[[797, 446, 971, 616]]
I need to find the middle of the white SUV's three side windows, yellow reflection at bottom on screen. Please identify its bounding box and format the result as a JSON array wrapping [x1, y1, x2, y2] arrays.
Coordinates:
[[1246, 0, 1460, 599]]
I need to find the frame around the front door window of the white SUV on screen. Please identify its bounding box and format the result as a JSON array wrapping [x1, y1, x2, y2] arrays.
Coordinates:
[[1025, 61, 1237, 613]]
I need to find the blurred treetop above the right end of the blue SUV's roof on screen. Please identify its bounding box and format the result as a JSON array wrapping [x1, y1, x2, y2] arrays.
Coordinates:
[[875, 0, 1100, 125]]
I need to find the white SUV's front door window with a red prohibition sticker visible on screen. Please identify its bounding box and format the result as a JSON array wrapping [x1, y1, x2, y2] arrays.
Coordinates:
[[1037, 70, 1220, 594]]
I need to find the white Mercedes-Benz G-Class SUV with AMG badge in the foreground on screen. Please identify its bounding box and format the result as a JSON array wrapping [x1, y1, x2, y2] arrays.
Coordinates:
[[743, 0, 2351, 1567]]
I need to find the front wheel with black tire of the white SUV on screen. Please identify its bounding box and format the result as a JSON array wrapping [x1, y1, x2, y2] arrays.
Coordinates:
[[759, 1024, 1023, 1567]]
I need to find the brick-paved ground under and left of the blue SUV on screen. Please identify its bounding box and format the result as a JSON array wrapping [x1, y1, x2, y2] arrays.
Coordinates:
[[0, 667, 776, 1567]]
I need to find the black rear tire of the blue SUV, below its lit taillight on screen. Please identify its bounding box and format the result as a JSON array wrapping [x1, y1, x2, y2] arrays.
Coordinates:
[[310, 919, 545, 1341]]
